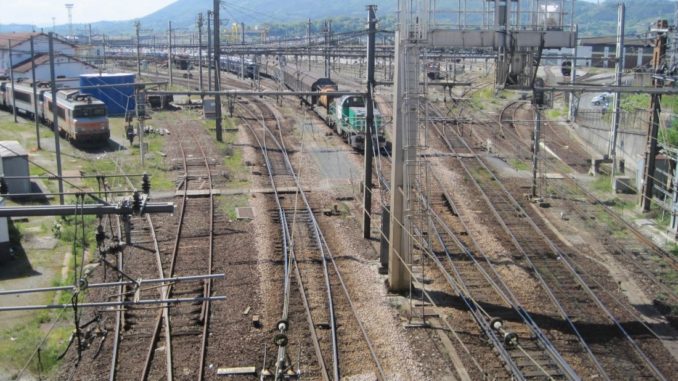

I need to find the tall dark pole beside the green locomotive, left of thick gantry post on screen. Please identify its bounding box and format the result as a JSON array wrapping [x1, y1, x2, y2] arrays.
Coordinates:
[[364, 5, 379, 239]]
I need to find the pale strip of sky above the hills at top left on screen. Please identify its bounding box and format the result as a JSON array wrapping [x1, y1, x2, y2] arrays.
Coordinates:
[[0, 0, 176, 27]]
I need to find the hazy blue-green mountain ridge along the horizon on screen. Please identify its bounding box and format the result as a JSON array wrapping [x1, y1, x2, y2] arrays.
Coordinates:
[[2, 0, 675, 37]]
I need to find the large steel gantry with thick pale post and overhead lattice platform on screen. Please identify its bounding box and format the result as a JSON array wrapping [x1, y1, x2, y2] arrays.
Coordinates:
[[388, 0, 576, 292]]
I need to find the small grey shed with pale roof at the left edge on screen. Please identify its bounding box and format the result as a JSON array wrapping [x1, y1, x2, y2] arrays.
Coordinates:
[[0, 140, 31, 195]]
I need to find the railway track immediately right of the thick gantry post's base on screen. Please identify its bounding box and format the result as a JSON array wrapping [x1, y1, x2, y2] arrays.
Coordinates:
[[429, 173, 579, 380]]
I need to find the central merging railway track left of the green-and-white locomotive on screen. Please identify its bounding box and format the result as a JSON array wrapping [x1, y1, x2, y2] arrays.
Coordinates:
[[238, 96, 386, 380]]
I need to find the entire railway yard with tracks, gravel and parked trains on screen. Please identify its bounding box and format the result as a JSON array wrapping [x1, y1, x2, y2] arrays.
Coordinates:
[[0, 2, 678, 381]]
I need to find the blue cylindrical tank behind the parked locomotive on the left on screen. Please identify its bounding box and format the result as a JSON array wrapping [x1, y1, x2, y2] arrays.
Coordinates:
[[80, 73, 136, 116]]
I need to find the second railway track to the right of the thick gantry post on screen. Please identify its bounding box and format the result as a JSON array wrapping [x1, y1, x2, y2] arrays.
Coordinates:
[[428, 100, 676, 379]]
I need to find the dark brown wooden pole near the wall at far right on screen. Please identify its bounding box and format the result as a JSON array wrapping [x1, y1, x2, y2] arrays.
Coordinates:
[[640, 20, 668, 212]]
